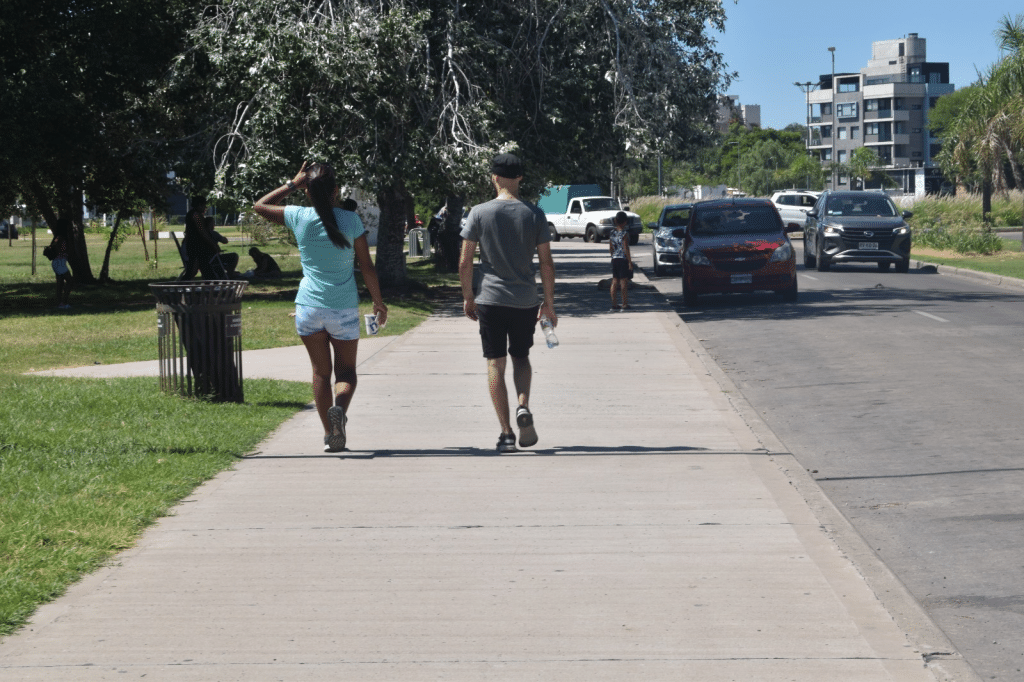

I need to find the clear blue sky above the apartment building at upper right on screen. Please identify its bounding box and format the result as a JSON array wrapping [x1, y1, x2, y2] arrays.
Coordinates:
[[713, 0, 1024, 128]]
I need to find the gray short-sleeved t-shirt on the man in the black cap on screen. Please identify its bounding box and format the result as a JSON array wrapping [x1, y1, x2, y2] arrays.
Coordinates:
[[462, 199, 551, 308]]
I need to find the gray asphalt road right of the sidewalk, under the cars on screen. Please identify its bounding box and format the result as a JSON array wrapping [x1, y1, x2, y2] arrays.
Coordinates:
[[633, 240, 1024, 680]]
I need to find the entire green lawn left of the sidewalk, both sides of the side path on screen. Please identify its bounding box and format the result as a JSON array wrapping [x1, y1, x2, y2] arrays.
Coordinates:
[[0, 232, 458, 635]]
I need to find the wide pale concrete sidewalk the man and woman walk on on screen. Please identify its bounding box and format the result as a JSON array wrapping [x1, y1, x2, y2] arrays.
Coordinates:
[[0, 242, 977, 682]]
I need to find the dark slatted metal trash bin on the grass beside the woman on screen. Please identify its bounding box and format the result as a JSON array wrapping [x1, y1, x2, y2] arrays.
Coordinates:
[[150, 281, 248, 402]]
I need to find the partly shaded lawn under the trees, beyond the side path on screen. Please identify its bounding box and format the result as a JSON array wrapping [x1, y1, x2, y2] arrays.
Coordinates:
[[0, 235, 448, 373]]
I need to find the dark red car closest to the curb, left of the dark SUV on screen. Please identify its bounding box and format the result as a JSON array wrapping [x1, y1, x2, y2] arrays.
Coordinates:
[[673, 199, 797, 306]]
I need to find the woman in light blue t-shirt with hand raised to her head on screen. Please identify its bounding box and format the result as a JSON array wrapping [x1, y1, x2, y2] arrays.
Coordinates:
[[253, 163, 387, 453]]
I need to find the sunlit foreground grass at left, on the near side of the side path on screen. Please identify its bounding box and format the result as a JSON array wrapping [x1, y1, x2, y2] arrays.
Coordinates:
[[0, 374, 310, 634]]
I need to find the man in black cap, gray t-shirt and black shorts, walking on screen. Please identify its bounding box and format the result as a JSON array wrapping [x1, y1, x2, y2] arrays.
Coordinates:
[[459, 154, 558, 453]]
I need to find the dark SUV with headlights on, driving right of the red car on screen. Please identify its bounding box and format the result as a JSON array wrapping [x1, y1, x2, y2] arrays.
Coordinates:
[[804, 190, 913, 272]]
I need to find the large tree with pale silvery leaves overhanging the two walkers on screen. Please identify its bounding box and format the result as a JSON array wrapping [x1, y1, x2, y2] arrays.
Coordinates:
[[167, 0, 727, 286]]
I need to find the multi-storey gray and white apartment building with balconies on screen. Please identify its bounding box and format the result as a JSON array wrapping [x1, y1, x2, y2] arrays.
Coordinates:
[[807, 33, 954, 195]]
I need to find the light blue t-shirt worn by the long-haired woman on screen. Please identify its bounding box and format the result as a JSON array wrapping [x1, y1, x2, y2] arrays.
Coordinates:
[[285, 201, 365, 310]]
